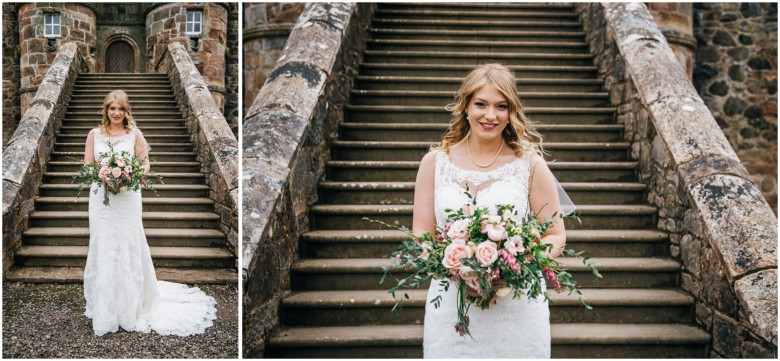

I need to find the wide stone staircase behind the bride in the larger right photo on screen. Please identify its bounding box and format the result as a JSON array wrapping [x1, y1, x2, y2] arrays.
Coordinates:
[[266, 3, 709, 358]]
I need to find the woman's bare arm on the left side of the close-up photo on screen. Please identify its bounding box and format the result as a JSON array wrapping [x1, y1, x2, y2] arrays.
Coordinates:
[[412, 152, 436, 236]]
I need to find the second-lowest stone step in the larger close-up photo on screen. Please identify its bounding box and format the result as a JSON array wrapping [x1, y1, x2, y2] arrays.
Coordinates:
[[282, 288, 693, 327]]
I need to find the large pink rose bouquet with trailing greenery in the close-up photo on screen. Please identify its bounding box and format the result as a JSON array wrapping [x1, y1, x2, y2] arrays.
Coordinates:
[[370, 189, 601, 336]]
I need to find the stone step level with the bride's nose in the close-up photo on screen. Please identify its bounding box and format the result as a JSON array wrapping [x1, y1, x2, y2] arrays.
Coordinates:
[[345, 104, 615, 124]]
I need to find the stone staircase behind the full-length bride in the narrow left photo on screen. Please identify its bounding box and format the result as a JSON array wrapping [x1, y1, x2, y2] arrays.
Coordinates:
[[6, 74, 237, 284]]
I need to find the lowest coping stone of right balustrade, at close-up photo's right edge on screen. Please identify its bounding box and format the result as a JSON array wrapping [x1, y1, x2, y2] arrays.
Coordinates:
[[734, 269, 777, 344]]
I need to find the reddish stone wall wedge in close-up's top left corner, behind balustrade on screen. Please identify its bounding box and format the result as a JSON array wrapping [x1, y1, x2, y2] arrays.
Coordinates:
[[243, 3, 303, 113]]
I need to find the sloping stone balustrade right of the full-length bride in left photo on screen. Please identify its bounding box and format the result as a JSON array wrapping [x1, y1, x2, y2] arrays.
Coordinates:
[[156, 42, 239, 255]]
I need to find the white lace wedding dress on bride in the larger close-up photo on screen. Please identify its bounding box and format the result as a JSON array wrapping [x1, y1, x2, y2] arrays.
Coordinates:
[[423, 151, 550, 359]]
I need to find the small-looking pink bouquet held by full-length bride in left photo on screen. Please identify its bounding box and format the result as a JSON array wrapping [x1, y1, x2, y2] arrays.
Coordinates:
[[73, 148, 164, 206]]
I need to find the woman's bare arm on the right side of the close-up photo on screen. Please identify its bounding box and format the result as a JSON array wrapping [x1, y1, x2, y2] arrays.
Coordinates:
[[530, 154, 566, 258]]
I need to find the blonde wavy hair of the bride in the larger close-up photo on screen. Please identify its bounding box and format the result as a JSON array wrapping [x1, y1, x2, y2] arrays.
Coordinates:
[[433, 63, 543, 157]]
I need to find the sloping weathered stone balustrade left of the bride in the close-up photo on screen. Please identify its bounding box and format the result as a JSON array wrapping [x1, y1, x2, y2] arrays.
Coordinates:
[[241, 3, 375, 357]]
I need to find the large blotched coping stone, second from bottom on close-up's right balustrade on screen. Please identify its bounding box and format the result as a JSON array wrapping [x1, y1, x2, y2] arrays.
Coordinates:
[[689, 175, 777, 280]]
